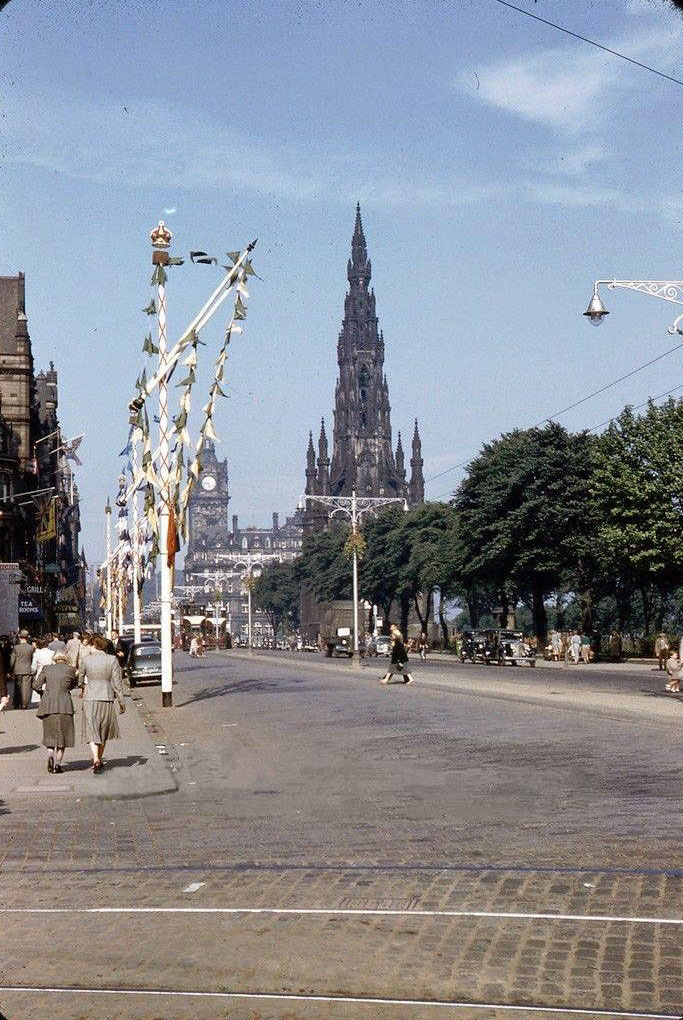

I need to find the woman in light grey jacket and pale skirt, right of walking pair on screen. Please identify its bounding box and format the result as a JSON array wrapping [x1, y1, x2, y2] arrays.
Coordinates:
[[78, 634, 125, 775]]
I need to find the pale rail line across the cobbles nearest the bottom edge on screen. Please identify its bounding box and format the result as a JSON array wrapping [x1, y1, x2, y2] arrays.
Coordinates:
[[0, 984, 681, 1020]]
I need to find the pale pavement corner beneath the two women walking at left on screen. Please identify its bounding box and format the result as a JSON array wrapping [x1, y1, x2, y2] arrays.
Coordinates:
[[0, 695, 177, 800]]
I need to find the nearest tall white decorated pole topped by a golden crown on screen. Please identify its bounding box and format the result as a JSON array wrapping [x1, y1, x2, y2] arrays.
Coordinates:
[[150, 221, 173, 708]]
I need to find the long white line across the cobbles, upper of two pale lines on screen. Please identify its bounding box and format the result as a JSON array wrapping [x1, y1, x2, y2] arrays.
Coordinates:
[[0, 907, 683, 930]]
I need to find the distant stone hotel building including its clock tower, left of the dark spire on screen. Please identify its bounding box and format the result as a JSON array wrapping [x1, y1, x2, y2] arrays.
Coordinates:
[[181, 441, 303, 645]]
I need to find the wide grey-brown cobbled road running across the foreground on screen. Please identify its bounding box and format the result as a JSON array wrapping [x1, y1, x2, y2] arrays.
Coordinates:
[[0, 656, 683, 1020]]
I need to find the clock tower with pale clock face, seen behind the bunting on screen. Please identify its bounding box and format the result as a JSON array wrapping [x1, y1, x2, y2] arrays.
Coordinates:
[[185, 440, 230, 574]]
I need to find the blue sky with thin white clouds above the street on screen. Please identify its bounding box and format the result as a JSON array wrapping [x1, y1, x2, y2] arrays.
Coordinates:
[[0, 0, 683, 562]]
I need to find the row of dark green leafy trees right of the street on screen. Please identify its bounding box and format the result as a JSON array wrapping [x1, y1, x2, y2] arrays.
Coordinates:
[[254, 400, 683, 641]]
